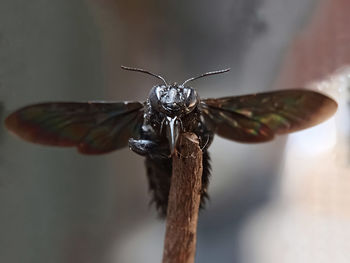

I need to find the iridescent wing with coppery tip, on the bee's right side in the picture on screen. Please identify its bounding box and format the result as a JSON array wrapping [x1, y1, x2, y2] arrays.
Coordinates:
[[202, 89, 337, 143]]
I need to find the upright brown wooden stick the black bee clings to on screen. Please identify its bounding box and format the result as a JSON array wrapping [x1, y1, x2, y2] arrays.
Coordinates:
[[163, 133, 203, 263]]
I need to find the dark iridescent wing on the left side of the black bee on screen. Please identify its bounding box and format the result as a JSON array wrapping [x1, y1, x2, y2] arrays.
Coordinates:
[[5, 102, 143, 154]]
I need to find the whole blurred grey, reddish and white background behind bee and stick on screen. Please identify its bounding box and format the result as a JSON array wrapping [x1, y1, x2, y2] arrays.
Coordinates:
[[0, 0, 350, 263]]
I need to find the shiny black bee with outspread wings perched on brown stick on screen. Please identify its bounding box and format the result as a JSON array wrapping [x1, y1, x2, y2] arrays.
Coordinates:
[[5, 66, 337, 216]]
